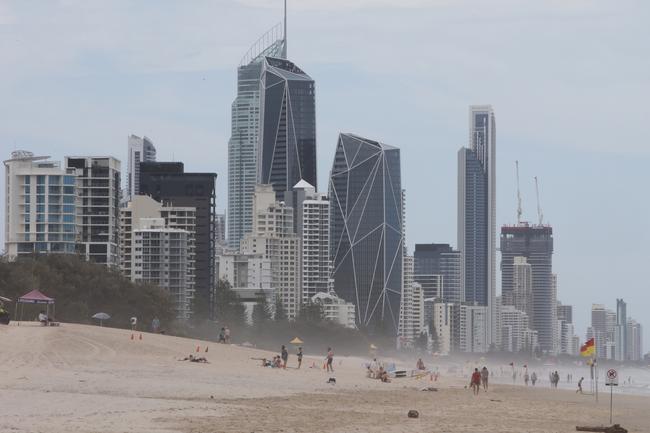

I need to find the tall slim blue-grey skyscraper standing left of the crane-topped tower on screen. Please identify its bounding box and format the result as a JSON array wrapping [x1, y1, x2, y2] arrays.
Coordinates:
[[458, 105, 497, 346]]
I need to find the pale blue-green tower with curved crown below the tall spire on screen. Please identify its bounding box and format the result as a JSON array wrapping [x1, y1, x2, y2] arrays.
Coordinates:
[[227, 25, 286, 249]]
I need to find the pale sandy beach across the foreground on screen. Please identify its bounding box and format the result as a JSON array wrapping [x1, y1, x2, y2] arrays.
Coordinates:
[[0, 323, 650, 433]]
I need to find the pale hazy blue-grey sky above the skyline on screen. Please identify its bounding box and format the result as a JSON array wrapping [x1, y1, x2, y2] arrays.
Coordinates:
[[0, 0, 650, 351]]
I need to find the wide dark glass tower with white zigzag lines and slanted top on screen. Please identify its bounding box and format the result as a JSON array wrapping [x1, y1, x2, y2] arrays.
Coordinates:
[[329, 134, 404, 335]]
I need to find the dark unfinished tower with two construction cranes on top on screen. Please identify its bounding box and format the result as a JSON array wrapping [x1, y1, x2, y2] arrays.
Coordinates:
[[501, 222, 557, 351]]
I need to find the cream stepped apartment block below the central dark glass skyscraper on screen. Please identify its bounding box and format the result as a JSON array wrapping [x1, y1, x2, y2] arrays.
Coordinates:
[[240, 185, 302, 319]]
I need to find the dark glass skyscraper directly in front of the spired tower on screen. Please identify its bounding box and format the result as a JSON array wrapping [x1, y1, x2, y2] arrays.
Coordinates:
[[258, 57, 318, 200]]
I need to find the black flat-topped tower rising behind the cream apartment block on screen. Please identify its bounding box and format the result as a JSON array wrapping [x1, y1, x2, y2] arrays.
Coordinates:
[[139, 162, 217, 314]]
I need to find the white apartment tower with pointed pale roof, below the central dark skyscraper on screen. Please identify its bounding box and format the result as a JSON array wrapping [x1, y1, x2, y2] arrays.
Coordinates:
[[285, 180, 334, 303]]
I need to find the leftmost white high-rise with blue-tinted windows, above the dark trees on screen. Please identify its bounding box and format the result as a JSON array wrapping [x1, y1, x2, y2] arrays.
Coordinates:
[[4, 151, 79, 258]]
